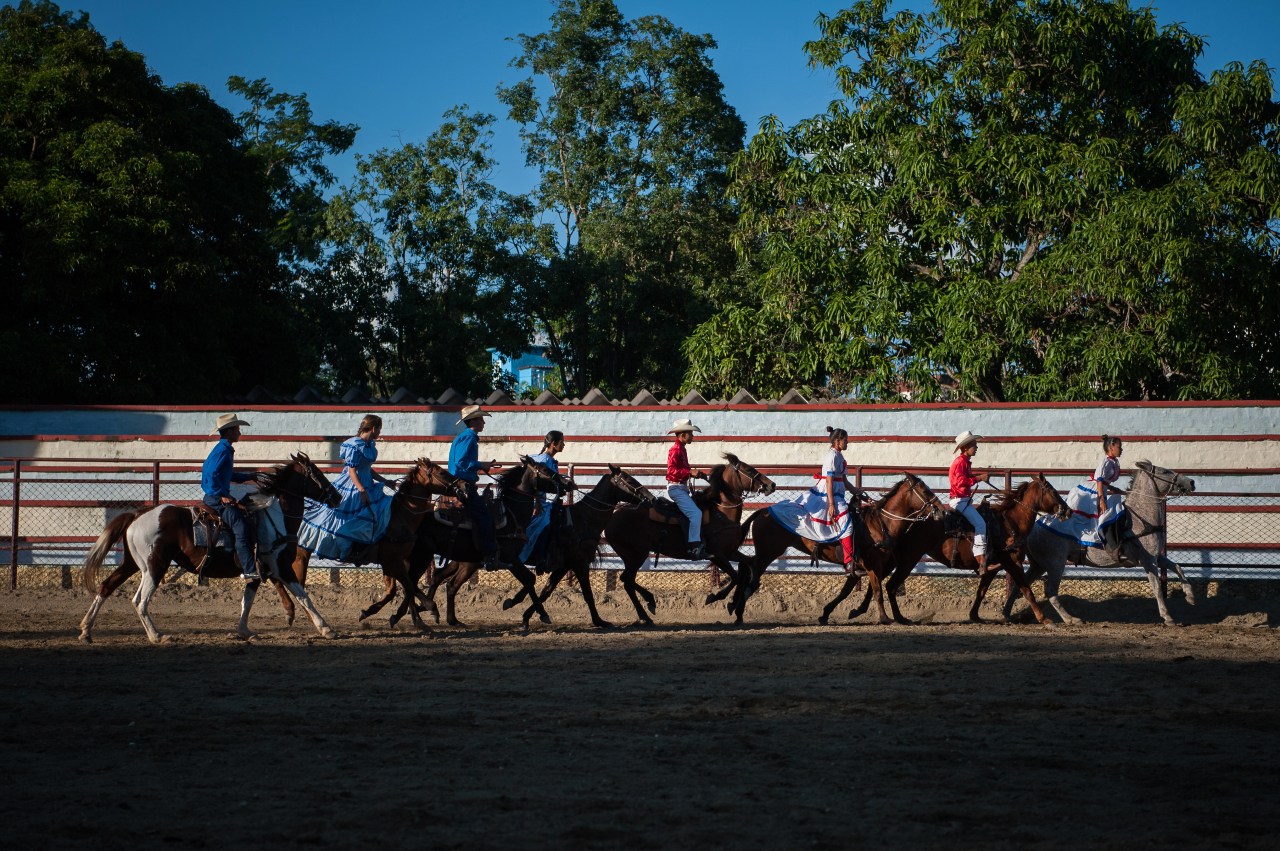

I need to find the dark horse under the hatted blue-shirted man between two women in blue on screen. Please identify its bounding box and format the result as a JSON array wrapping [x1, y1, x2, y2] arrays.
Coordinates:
[[360, 456, 560, 626]]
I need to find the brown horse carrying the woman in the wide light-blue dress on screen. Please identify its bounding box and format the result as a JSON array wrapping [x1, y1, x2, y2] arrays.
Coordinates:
[[293, 458, 466, 632]]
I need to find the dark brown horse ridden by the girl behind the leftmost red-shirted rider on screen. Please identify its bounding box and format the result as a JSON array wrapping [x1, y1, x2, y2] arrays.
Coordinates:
[[483, 465, 653, 630]]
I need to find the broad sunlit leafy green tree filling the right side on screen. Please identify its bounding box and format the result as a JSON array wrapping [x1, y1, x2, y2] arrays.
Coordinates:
[[686, 0, 1280, 401]]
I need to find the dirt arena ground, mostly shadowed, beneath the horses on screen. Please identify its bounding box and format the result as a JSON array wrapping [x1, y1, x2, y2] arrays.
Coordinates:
[[0, 570, 1280, 848]]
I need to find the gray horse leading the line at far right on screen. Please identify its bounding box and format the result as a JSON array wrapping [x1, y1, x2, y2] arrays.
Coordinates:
[[1005, 461, 1196, 626]]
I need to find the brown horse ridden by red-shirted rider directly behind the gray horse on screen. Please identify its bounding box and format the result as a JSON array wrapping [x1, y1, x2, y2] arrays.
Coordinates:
[[820, 475, 1069, 623]]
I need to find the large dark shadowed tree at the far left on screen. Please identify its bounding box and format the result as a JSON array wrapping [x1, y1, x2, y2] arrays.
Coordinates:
[[0, 1, 300, 403]]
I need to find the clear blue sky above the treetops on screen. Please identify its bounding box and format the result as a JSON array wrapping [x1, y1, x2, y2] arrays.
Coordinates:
[[61, 0, 1280, 192]]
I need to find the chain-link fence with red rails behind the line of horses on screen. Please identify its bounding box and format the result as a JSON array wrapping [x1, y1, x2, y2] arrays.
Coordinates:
[[0, 459, 1280, 585]]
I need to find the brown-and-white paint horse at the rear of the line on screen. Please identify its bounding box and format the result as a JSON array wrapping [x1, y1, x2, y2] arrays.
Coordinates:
[[79, 452, 342, 644]]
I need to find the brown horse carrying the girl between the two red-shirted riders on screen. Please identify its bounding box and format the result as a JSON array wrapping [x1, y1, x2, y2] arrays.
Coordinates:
[[730, 473, 945, 623]]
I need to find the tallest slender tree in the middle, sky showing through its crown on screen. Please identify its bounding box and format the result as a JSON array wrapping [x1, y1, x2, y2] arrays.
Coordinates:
[[498, 0, 744, 394]]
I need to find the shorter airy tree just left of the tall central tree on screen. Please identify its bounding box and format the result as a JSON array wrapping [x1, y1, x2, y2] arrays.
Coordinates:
[[305, 106, 539, 395]]
